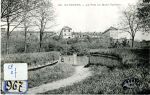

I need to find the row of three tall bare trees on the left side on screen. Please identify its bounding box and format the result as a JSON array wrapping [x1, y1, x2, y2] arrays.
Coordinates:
[[1, 0, 54, 54]]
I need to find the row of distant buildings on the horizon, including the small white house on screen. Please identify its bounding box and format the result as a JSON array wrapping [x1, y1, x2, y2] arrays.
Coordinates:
[[60, 26, 130, 47]]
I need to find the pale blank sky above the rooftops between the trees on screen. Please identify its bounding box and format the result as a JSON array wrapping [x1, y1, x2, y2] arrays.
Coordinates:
[[52, 0, 137, 32]]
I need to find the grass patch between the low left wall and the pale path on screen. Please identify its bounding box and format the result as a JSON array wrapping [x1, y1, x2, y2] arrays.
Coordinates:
[[28, 63, 74, 88]]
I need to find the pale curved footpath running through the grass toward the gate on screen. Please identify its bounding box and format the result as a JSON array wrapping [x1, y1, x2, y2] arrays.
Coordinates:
[[27, 66, 92, 93]]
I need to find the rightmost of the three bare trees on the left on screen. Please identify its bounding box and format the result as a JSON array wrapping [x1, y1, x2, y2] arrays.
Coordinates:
[[33, 0, 54, 51]]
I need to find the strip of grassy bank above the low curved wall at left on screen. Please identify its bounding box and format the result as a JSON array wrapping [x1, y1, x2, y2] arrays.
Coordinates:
[[1, 52, 59, 66]]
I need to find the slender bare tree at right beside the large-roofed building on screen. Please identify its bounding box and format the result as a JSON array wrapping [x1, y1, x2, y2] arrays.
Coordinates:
[[121, 6, 140, 47]]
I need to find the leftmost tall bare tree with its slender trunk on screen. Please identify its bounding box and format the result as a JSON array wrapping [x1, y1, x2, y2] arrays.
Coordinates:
[[1, 0, 21, 54]]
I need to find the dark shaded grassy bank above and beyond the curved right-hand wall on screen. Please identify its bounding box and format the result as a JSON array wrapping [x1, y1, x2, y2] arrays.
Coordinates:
[[91, 48, 150, 68]]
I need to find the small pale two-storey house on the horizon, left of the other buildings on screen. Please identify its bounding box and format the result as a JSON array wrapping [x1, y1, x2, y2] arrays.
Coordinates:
[[60, 26, 74, 39]]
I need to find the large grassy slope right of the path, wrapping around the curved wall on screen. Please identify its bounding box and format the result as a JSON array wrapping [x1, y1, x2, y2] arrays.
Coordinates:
[[46, 49, 150, 94]]
